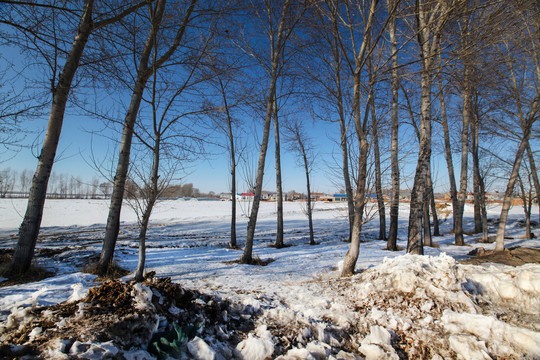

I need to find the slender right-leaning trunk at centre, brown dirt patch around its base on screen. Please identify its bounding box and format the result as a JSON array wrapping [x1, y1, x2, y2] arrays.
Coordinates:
[[240, 0, 290, 264]]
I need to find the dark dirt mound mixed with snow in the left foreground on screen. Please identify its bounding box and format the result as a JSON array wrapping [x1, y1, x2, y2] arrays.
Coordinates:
[[0, 278, 257, 358]]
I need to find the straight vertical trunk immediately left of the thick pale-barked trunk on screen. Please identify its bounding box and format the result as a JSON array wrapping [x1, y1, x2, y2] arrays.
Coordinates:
[[386, 0, 399, 251]]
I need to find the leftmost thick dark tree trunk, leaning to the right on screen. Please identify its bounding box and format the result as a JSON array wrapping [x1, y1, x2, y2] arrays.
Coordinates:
[[10, 0, 94, 275]]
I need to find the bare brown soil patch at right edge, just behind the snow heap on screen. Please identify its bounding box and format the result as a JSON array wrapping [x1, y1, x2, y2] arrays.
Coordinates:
[[460, 246, 540, 266]]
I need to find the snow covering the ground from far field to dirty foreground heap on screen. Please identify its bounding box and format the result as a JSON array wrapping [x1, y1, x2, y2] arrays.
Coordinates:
[[0, 199, 540, 360]]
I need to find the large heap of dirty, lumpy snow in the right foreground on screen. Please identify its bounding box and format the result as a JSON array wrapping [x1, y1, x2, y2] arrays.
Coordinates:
[[344, 254, 540, 359]]
